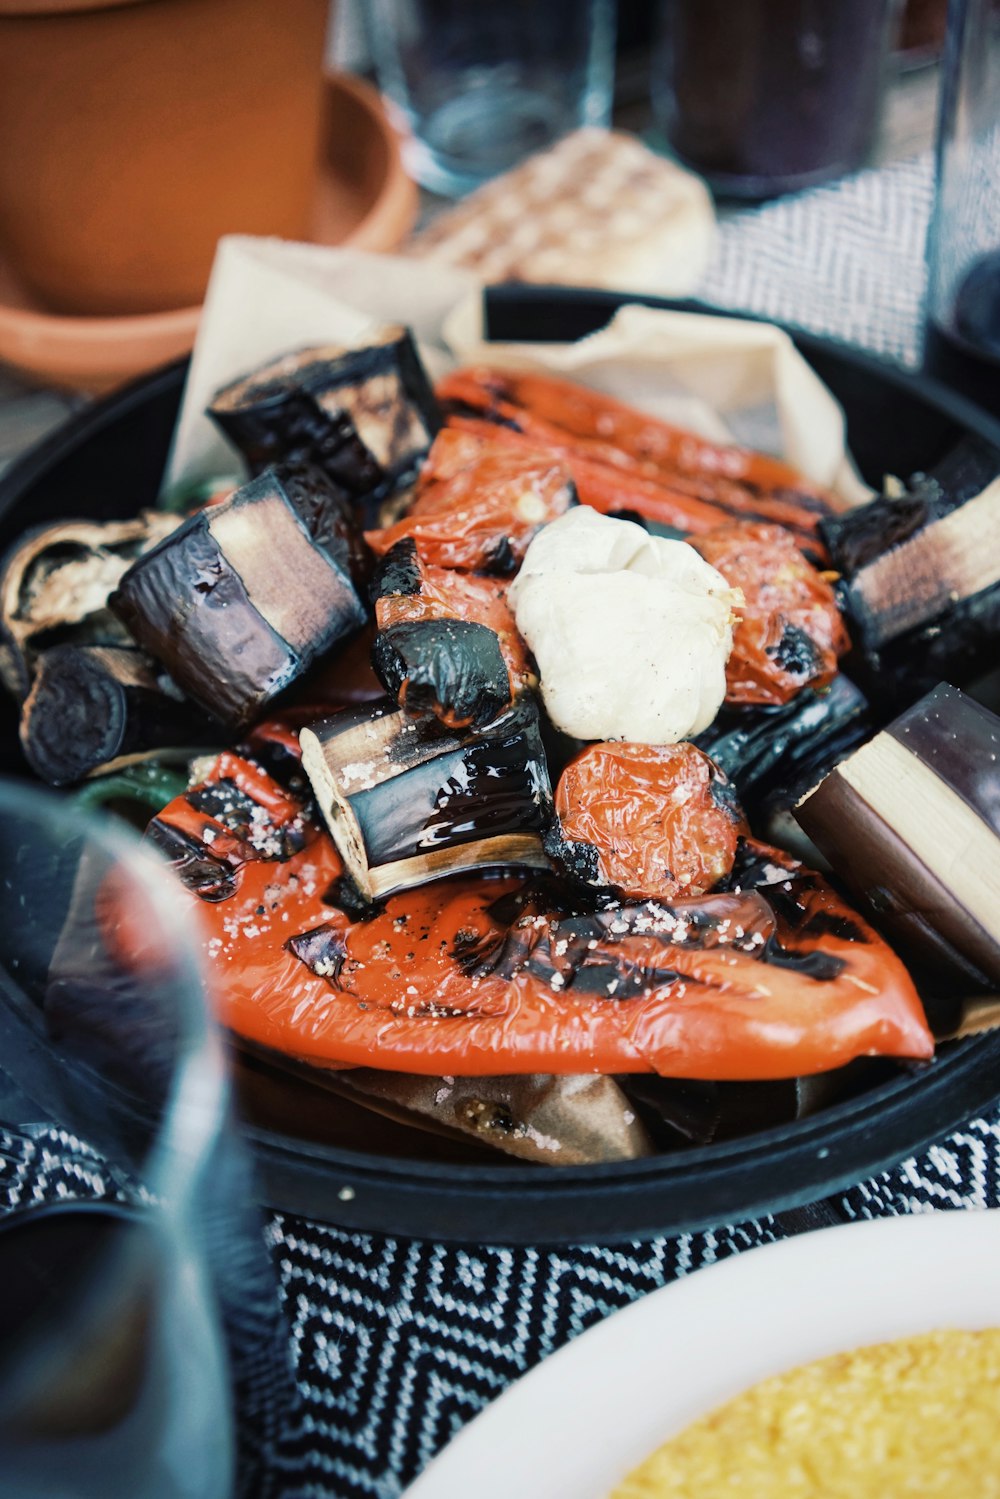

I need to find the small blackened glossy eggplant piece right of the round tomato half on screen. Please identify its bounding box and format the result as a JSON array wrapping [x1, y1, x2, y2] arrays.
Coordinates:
[[694, 675, 873, 812]]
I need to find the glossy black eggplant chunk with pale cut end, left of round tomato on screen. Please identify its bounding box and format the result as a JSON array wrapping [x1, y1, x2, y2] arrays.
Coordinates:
[[300, 699, 552, 901]]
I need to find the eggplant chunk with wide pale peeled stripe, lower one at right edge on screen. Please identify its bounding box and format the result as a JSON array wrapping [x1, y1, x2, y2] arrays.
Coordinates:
[[795, 687, 1000, 992]]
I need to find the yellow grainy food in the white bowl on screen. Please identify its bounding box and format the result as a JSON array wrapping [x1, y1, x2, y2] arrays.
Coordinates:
[[612, 1328, 1000, 1499]]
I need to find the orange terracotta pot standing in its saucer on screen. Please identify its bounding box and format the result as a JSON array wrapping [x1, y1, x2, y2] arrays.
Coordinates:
[[0, 0, 330, 315]]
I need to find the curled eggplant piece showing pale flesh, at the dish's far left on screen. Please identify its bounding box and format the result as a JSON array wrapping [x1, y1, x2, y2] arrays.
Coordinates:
[[0, 511, 178, 697]]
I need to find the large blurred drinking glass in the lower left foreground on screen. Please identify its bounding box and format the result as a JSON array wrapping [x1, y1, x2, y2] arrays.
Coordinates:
[[0, 782, 291, 1499]]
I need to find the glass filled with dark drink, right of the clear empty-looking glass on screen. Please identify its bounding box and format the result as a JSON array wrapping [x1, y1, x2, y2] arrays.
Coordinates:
[[651, 0, 897, 198]]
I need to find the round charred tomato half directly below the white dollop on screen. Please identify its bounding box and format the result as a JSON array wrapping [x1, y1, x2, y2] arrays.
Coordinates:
[[546, 744, 745, 901]]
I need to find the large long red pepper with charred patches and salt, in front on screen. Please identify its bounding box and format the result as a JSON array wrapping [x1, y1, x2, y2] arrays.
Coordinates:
[[146, 755, 933, 1081]]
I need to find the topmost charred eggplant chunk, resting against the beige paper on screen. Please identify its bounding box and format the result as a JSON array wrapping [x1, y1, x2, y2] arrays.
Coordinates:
[[208, 327, 439, 499]]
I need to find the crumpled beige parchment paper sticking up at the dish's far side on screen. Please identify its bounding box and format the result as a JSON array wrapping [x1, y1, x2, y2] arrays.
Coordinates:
[[165, 235, 870, 505]]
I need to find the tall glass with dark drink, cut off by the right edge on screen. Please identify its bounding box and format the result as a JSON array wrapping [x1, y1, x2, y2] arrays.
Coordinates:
[[925, 0, 1000, 414]]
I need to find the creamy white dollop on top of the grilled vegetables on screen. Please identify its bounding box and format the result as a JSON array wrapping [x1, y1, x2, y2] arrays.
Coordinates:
[[508, 505, 742, 745]]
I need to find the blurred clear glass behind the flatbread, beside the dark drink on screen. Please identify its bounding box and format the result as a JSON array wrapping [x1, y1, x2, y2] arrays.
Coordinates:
[[366, 0, 615, 196]]
